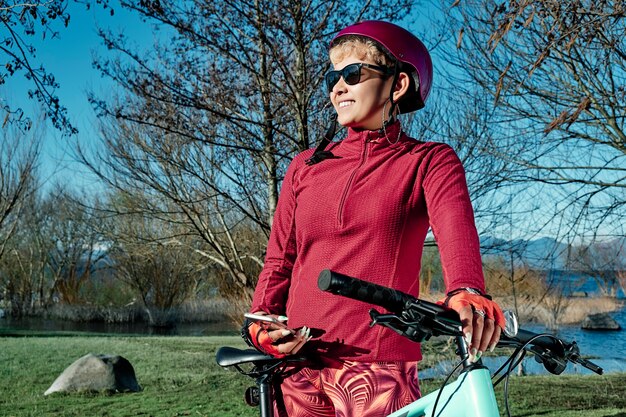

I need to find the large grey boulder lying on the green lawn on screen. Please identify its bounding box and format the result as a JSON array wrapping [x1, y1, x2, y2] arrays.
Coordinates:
[[44, 353, 141, 395]]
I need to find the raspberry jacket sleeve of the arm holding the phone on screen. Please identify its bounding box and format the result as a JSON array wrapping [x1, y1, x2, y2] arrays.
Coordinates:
[[250, 157, 302, 314]]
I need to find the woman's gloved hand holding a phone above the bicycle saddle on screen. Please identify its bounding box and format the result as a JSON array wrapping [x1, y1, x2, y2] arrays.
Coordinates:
[[248, 311, 311, 358]]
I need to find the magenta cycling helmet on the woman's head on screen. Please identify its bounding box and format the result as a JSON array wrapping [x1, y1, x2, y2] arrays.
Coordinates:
[[330, 20, 433, 113]]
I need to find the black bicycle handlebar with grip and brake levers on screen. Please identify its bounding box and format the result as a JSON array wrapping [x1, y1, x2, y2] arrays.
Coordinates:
[[317, 269, 602, 374]]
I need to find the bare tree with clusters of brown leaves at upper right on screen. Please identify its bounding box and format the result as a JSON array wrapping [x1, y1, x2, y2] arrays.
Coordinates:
[[438, 0, 626, 236]]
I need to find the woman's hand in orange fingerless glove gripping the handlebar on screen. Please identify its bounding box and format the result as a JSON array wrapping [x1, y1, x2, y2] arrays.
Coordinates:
[[442, 291, 505, 362]]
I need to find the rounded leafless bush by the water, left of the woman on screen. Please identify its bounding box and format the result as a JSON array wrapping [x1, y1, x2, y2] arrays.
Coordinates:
[[100, 193, 208, 326]]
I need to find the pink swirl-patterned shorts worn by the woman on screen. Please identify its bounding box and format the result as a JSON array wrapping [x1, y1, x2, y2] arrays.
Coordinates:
[[274, 361, 420, 417]]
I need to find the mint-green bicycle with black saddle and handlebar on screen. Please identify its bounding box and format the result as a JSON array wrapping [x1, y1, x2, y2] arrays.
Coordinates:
[[217, 270, 603, 417]]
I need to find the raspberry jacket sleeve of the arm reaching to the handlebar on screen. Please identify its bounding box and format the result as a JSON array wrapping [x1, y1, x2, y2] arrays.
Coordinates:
[[424, 145, 485, 292]]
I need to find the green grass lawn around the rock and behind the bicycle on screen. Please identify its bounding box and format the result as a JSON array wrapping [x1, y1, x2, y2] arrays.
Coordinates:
[[0, 333, 626, 417]]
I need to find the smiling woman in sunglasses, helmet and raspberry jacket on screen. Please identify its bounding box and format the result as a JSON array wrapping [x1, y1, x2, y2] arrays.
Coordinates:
[[243, 21, 504, 416]]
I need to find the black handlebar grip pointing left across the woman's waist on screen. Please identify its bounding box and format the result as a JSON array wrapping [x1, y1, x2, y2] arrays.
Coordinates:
[[317, 269, 416, 314]]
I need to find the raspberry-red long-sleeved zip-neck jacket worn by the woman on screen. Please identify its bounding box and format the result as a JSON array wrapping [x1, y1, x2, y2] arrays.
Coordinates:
[[251, 123, 484, 361]]
